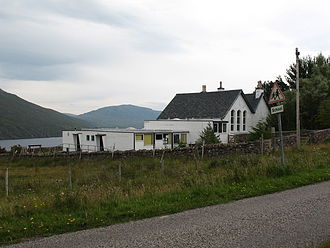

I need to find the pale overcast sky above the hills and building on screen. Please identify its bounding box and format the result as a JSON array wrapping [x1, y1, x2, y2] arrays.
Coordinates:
[[0, 0, 330, 114]]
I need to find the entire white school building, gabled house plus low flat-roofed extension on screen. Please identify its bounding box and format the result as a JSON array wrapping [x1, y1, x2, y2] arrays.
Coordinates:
[[63, 82, 269, 152]]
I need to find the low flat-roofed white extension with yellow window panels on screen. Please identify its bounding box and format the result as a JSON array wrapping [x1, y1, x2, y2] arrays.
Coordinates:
[[62, 128, 190, 152]]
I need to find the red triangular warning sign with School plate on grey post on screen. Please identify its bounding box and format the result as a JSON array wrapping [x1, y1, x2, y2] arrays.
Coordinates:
[[268, 82, 285, 168]]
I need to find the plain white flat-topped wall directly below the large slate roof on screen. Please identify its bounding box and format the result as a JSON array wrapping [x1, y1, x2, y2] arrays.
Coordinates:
[[144, 120, 212, 144]]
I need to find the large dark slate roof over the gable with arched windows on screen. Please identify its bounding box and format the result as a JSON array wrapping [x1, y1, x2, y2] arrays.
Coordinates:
[[157, 90, 255, 120]]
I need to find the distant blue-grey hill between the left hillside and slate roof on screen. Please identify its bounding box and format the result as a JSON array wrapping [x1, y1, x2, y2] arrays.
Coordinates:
[[78, 105, 160, 128]]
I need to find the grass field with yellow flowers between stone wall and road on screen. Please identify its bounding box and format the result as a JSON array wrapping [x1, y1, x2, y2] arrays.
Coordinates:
[[0, 144, 330, 245]]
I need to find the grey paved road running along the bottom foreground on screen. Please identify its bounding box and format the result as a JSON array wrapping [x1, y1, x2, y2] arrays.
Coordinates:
[[5, 181, 330, 248]]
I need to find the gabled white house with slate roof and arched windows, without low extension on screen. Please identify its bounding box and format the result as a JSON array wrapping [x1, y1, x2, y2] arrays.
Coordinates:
[[144, 82, 269, 144]]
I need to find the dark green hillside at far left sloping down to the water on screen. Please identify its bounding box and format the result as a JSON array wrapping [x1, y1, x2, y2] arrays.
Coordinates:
[[0, 89, 91, 139]]
